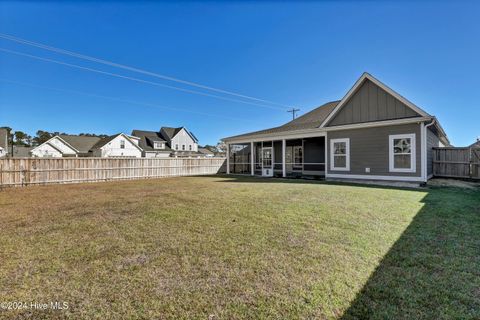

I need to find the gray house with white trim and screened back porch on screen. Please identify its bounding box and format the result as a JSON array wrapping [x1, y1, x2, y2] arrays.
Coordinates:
[[223, 73, 450, 183]]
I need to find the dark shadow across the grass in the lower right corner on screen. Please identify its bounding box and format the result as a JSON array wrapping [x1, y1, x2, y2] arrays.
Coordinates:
[[341, 188, 480, 319]]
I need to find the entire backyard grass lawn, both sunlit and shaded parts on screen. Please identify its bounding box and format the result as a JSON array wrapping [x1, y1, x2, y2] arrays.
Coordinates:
[[0, 176, 480, 319]]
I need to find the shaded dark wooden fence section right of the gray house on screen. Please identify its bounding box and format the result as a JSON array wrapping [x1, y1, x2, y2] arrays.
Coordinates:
[[433, 147, 480, 179]]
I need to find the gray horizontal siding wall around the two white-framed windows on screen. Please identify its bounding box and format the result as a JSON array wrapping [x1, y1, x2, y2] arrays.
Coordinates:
[[327, 123, 422, 177]]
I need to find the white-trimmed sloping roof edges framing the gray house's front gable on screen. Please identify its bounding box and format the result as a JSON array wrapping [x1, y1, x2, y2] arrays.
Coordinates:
[[320, 72, 431, 128]]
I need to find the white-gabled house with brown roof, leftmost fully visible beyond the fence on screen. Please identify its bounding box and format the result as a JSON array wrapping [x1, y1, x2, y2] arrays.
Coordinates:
[[31, 134, 101, 158]]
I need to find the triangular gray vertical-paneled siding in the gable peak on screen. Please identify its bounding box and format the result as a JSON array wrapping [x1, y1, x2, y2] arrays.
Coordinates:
[[328, 80, 420, 126]]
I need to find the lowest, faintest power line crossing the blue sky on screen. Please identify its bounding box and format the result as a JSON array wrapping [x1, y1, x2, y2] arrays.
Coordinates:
[[0, 78, 255, 122]]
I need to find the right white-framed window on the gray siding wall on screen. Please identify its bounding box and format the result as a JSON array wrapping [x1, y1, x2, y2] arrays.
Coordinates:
[[389, 133, 415, 172]]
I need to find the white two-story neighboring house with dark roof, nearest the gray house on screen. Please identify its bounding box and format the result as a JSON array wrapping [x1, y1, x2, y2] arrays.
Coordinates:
[[132, 127, 202, 158]]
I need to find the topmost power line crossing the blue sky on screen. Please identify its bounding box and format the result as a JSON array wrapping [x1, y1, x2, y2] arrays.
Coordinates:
[[0, 33, 287, 108]]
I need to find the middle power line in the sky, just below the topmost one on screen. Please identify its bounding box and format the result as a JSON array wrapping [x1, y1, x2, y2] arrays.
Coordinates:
[[0, 48, 284, 110]]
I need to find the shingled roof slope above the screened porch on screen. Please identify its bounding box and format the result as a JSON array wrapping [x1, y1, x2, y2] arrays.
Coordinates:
[[223, 100, 340, 141]]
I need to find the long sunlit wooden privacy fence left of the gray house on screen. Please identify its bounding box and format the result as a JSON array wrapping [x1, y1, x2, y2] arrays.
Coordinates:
[[0, 158, 225, 187]]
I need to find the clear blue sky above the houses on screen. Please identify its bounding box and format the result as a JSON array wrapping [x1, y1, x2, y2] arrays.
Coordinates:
[[0, 1, 480, 146]]
